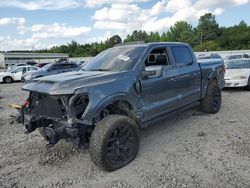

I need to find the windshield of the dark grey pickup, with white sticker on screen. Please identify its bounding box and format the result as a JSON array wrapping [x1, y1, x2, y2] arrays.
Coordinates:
[[82, 46, 145, 72]]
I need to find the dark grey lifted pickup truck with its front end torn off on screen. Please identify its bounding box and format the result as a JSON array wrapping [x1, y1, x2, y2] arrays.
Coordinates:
[[18, 43, 224, 171]]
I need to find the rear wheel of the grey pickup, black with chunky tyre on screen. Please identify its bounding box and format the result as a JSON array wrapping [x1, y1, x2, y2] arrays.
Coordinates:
[[201, 81, 221, 114]]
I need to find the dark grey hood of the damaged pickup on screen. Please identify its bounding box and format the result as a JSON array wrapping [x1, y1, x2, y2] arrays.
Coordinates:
[[23, 71, 134, 95]]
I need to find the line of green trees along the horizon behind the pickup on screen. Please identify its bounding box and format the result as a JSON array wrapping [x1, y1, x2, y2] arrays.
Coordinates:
[[30, 13, 250, 57]]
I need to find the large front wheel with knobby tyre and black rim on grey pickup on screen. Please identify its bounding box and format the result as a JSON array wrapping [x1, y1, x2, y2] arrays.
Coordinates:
[[90, 115, 140, 171]]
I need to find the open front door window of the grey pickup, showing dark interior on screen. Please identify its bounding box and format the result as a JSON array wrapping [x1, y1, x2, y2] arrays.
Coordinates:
[[145, 48, 170, 67]]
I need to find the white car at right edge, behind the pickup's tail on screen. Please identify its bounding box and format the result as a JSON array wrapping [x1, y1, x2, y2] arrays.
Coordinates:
[[224, 59, 250, 91]]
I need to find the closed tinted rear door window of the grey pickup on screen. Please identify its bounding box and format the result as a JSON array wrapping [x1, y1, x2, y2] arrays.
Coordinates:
[[171, 46, 193, 66]]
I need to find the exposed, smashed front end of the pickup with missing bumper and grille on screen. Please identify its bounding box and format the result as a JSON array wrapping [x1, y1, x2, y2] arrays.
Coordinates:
[[22, 91, 93, 146]]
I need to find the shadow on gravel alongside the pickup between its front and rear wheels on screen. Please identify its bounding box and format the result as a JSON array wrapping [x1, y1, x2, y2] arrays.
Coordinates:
[[139, 107, 208, 155]]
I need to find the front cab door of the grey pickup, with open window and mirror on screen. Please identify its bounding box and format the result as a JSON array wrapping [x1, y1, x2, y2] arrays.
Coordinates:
[[141, 48, 179, 122]]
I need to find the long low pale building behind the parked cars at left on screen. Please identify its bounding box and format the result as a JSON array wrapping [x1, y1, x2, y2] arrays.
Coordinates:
[[0, 52, 69, 68]]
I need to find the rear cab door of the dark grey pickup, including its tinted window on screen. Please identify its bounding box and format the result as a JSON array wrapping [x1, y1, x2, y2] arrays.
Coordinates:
[[170, 45, 201, 106]]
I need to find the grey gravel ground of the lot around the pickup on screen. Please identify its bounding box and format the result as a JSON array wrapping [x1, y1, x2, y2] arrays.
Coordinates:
[[0, 83, 250, 188]]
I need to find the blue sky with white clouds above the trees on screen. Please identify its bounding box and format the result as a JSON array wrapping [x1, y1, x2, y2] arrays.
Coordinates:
[[0, 0, 250, 51]]
